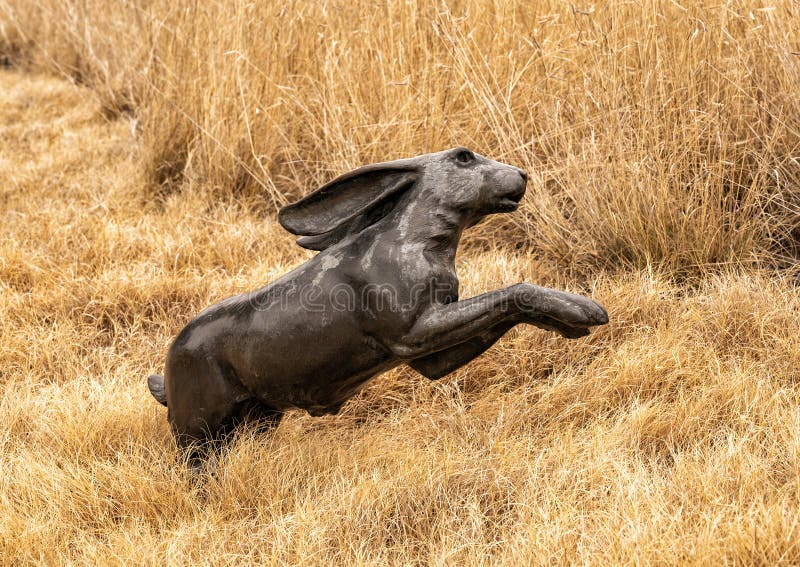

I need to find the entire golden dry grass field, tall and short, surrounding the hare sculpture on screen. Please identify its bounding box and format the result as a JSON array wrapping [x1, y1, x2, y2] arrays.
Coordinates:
[[0, 0, 800, 565]]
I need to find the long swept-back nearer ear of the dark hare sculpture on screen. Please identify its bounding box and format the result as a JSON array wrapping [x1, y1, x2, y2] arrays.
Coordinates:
[[278, 160, 418, 237]]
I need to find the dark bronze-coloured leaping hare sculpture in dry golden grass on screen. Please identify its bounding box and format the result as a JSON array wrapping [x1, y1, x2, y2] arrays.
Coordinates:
[[148, 148, 608, 459]]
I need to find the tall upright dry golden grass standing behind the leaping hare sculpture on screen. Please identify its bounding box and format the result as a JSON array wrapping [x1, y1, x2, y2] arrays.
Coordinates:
[[0, 0, 800, 276]]
